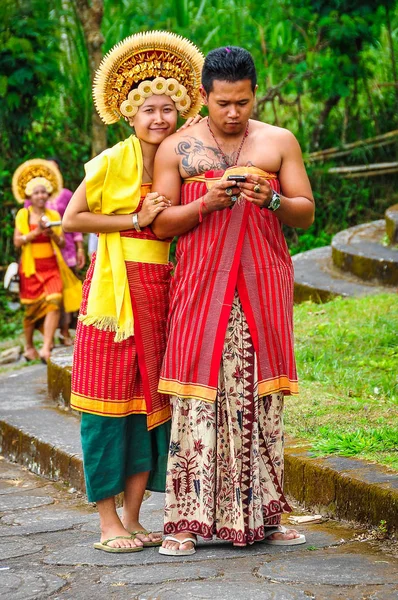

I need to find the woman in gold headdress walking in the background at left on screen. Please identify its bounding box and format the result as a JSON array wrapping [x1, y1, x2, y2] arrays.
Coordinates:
[[13, 159, 81, 362]]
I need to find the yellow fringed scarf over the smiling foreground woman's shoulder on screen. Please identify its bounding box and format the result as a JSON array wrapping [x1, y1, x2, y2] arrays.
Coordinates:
[[79, 136, 146, 342]]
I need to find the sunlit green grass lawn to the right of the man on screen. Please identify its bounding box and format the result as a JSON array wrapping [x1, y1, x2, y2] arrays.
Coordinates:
[[285, 294, 398, 470]]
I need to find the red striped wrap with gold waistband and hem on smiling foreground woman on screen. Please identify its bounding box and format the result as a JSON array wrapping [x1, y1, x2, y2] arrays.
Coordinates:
[[71, 186, 171, 429]]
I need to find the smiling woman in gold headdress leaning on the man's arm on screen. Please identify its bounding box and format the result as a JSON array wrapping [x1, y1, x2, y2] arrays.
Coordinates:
[[63, 32, 203, 552]]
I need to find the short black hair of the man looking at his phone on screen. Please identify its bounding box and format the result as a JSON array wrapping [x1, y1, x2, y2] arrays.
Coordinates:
[[202, 46, 257, 94]]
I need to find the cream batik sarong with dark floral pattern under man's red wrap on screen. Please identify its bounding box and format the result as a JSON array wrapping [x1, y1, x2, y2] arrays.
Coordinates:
[[164, 294, 291, 546]]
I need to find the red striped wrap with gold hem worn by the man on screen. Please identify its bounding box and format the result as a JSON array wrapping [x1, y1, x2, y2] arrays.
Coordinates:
[[159, 167, 298, 402]]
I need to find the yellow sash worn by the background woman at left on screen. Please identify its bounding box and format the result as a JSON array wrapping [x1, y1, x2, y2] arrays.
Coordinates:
[[15, 208, 82, 313]]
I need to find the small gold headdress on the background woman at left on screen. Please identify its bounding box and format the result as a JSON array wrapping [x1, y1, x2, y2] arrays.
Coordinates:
[[12, 158, 63, 204]]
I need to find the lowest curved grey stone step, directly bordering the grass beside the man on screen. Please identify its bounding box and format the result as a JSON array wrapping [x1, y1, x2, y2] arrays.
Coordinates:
[[292, 246, 398, 304]]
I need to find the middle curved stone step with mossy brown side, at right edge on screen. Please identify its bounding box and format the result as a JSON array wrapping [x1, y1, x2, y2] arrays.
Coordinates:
[[332, 220, 398, 286]]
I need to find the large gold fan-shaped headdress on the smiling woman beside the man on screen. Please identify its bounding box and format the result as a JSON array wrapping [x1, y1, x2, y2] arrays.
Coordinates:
[[93, 31, 204, 125]]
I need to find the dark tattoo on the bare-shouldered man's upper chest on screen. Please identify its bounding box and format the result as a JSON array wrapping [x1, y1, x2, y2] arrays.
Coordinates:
[[176, 136, 243, 177]]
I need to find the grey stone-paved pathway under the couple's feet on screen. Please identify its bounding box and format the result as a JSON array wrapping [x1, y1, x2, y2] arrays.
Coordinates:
[[0, 459, 398, 600]]
